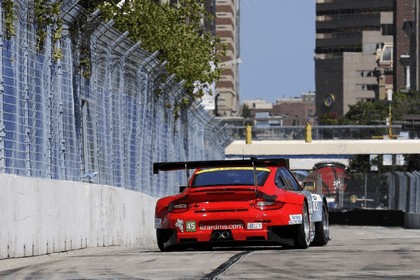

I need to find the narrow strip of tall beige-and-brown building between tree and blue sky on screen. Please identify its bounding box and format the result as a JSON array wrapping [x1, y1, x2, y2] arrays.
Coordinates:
[[216, 0, 240, 116]]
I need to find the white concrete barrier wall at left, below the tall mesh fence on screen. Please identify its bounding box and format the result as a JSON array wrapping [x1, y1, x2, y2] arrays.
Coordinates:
[[0, 174, 157, 259]]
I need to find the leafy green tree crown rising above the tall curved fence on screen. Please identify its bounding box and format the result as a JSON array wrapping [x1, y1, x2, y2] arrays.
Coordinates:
[[99, 0, 223, 107]]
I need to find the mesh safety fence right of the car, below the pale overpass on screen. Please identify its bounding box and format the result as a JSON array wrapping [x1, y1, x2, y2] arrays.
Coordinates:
[[295, 165, 420, 214]]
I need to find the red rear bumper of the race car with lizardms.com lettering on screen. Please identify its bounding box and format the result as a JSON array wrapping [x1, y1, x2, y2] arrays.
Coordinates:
[[155, 207, 301, 246]]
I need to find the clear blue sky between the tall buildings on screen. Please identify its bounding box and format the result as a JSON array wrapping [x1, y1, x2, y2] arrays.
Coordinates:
[[239, 0, 316, 103]]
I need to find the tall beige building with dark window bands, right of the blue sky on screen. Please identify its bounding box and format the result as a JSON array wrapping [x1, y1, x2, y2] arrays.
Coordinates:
[[315, 0, 398, 120]]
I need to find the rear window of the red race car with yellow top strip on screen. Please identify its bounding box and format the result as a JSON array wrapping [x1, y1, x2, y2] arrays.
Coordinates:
[[192, 167, 270, 187]]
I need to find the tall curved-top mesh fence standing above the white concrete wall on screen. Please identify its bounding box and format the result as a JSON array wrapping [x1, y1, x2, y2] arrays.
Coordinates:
[[0, 0, 231, 196]]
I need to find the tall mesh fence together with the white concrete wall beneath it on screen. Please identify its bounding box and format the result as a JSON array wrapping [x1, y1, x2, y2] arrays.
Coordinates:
[[0, 0, 231, 258]]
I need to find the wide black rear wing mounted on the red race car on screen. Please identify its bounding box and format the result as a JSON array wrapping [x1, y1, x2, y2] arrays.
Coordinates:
[[153, 158, 289, 174]]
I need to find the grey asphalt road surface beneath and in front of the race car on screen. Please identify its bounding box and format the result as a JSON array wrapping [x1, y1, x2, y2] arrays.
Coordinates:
[[0, 226, 420, 279]]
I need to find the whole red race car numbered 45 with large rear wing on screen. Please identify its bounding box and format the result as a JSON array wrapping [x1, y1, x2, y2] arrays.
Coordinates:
[[153, 158, 329, 251]]
